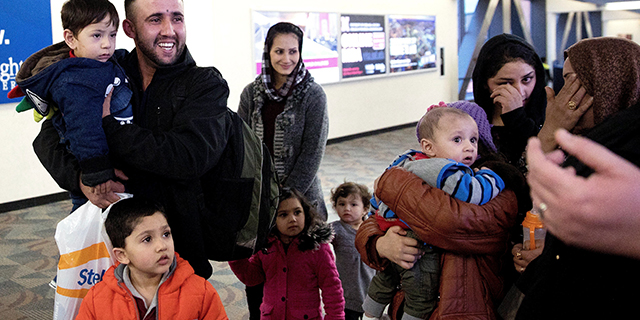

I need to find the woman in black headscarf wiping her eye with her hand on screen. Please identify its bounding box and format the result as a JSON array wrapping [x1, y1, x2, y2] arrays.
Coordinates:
[[473, 34, 547, 171]]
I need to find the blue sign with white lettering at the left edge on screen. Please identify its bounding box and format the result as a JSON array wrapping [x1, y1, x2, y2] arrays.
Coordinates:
[[0, 0, 52, 104]]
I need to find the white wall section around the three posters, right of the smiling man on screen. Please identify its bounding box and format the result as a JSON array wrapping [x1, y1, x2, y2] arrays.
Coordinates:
[[210, 0, 457, 138]]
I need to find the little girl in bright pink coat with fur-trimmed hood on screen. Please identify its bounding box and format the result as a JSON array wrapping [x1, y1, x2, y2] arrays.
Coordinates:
[[229, 188, 344, 320]]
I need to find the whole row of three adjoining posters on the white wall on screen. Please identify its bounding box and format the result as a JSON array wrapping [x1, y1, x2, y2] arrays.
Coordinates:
[[253, 11, 438, 83]]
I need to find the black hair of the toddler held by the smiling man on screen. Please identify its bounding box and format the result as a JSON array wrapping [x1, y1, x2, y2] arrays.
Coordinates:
[[60, 0, 120, 37]]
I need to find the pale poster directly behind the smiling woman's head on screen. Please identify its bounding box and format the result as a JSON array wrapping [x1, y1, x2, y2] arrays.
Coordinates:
[[252, 11, 340, 83]]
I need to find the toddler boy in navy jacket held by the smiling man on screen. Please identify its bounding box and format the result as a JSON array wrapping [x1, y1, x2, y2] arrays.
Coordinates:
[[8, 0, 133, 209]]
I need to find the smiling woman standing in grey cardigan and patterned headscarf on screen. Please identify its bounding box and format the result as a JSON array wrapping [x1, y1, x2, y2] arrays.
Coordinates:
[[238, 22, 329, 320]]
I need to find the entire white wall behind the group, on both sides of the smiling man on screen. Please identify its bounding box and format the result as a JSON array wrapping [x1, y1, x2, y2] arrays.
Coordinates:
[[0, 0, 458, 203]]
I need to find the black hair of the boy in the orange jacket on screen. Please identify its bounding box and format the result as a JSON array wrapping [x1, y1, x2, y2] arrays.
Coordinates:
[[104, 197, 167, 248]]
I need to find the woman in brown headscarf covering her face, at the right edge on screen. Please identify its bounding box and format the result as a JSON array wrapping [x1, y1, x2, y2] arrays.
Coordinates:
[[517, 38, 640, 319]]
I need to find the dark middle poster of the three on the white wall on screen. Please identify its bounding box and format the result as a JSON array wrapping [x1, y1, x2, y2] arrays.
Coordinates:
[[340, 14, 387, 78]]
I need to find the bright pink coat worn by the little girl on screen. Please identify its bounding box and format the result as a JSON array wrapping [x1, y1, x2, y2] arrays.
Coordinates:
[[229, 230, 344, 320]]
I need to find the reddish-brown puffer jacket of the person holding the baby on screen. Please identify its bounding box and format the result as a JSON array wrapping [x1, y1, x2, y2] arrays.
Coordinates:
[[356, 168, 518, 320]]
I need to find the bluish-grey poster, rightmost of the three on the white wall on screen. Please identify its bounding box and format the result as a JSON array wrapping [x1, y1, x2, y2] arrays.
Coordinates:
[[388, 15, 437, 73]]
